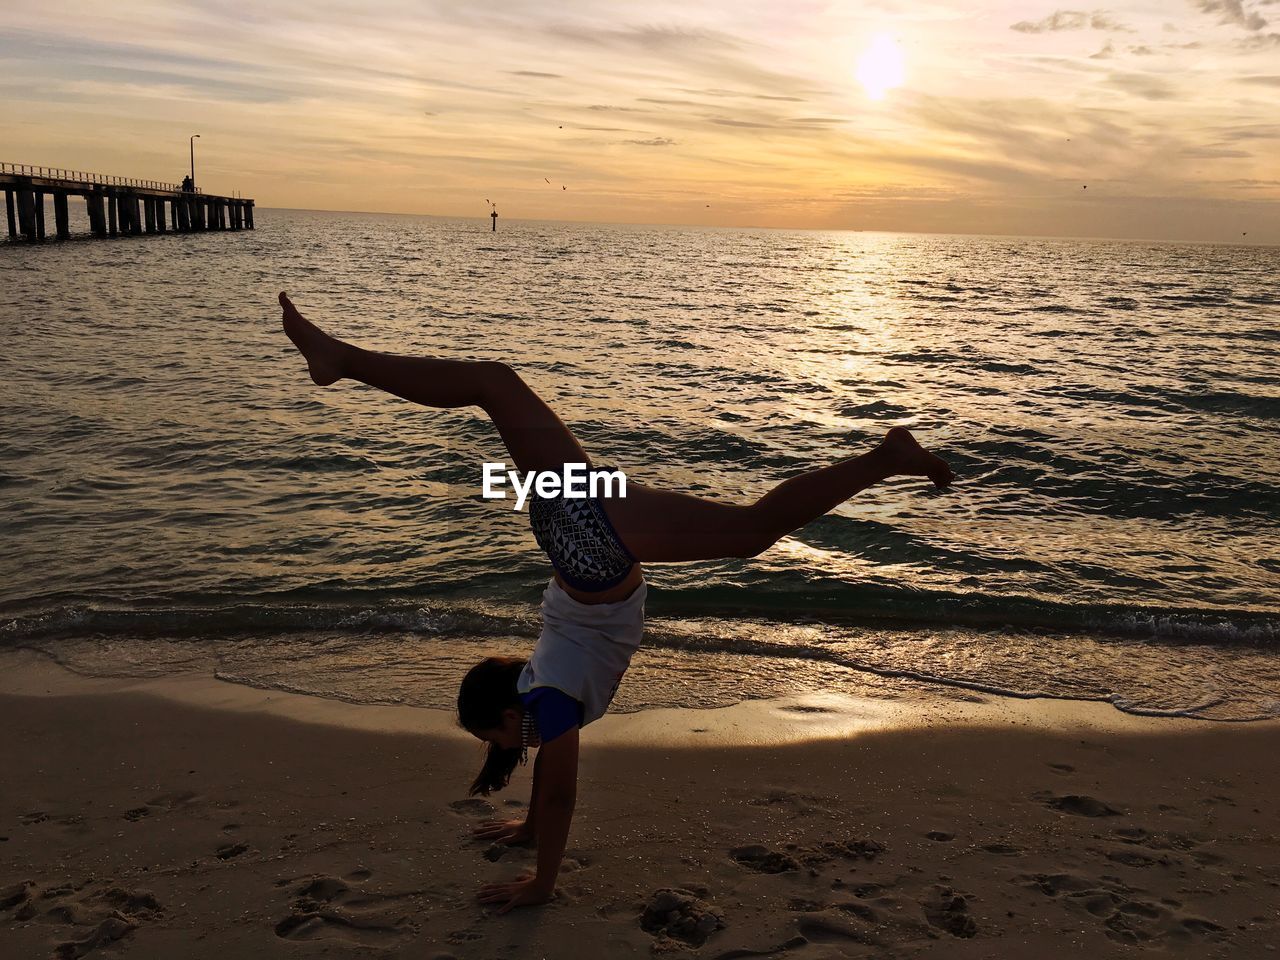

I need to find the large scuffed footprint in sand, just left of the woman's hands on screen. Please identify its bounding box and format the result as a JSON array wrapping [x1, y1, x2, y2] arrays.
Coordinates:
[[275, 868, 413, 947]]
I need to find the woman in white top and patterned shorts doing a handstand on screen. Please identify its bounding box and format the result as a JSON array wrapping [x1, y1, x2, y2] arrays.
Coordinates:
[[280, 293, 952, 913]]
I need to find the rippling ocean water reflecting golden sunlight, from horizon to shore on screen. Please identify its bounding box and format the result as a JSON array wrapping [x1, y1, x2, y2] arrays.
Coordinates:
[[0, 210, 1280, 721]]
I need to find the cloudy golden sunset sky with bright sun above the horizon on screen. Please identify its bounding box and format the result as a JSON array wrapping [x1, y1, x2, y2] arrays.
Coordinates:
[[0, 0, 1280, 243]]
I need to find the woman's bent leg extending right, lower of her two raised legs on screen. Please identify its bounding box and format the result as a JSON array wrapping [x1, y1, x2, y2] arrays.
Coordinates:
[[604, 426, 952, 563]]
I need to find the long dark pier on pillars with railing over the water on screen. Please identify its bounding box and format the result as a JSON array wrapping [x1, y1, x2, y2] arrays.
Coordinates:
[[0, 163, 253, 243]]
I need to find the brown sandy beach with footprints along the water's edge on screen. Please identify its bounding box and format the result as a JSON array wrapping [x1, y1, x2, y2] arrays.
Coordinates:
[[0, 654, 1280, 960]]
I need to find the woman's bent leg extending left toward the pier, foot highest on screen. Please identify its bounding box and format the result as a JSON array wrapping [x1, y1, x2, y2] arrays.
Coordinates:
[[280, 293, 591, 471]]
